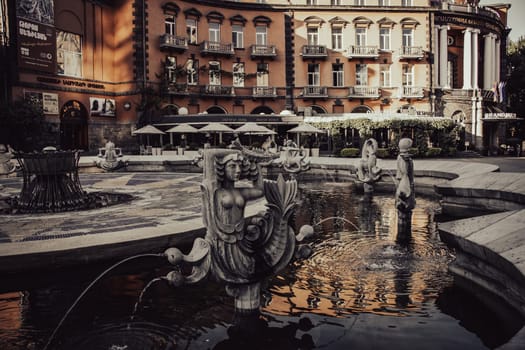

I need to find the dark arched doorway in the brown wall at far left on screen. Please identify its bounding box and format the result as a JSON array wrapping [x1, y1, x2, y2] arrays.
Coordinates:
[[60, 100, 89, 151]]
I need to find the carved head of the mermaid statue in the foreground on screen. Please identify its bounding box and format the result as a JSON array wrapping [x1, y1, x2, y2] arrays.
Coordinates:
[[215, 152, 257, 182]]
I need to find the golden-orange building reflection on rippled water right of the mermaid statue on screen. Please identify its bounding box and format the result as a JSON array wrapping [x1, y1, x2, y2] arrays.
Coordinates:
[[266, 187, 452, 316]]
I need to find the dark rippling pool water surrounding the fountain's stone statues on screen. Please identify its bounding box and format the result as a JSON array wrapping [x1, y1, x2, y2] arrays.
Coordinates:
[[0, 183, 523, 350]]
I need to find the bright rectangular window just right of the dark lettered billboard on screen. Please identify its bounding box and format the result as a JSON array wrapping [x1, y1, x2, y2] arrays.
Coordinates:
[[57, 30, 82, 78]]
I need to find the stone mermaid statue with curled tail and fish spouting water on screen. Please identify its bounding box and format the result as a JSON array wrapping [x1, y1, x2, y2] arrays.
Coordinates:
[[166, 149, 310, 314]]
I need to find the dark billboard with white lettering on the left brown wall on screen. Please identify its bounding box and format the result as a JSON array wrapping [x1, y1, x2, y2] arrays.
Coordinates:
[[17, 19, 56, 73]]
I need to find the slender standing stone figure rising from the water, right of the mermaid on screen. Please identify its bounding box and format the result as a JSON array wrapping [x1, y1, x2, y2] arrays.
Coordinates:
[[395, 138, 416, 243]]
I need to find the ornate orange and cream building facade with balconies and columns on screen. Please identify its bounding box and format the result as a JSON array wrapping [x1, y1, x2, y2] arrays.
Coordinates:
[[1, 0, 513, 150]]
